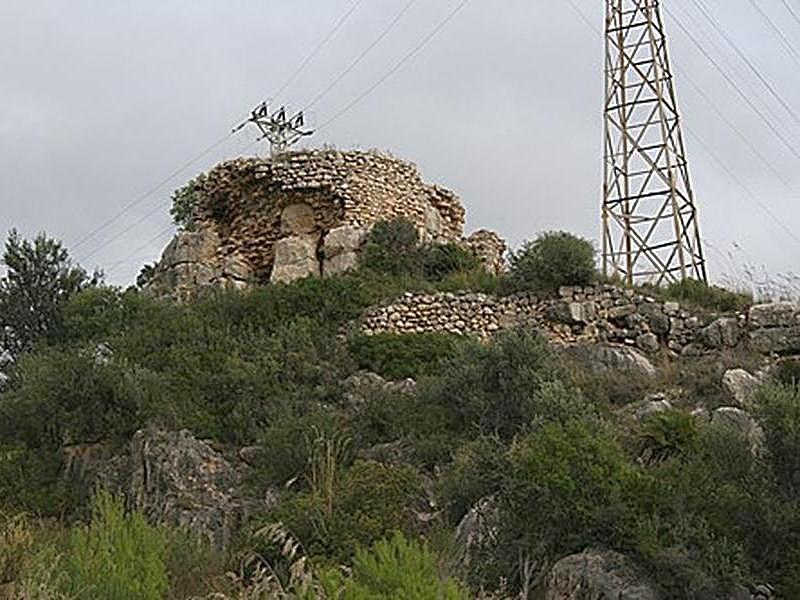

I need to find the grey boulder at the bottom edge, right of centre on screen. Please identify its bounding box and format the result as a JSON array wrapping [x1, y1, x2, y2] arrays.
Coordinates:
[[544, 550, 661, 600]]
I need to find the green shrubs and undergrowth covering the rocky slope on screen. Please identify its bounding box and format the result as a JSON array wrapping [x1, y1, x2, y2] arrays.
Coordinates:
[[0, 223, 800, 599]]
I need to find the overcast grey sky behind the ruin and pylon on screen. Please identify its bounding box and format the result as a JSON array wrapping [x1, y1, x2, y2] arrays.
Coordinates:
[[0, 0, 800, 284]]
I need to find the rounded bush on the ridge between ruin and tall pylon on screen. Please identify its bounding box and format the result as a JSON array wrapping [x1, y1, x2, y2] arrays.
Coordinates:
[[509, 231, 596, 292]]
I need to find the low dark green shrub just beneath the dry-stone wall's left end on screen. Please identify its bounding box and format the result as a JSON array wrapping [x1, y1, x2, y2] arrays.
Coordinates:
[[348, 333, 465, 379]]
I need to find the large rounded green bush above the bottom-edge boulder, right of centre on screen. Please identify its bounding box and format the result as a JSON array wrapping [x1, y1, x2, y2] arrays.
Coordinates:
[[500, 422, 640, 572]]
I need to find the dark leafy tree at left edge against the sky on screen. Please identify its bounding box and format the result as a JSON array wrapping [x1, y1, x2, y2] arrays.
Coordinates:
[[0, 230, 102, 362]]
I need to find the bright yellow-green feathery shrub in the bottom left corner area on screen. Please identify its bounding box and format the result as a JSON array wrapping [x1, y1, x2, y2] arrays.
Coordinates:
[[64, 493, 169, 600]]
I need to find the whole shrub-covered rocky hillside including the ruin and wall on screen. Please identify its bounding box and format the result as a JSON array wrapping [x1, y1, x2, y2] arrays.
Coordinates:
[[0, 153, 800, 600]]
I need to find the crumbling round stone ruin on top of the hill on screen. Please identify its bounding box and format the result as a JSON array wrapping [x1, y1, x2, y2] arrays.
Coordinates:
[[148, 150, 506, 298]]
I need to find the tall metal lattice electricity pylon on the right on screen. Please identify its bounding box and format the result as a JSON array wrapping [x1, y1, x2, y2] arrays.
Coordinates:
[[603, 0, 707, 284]]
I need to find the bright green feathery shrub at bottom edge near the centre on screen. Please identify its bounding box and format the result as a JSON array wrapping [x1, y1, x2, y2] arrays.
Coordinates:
[[341, 532, 472, 600]]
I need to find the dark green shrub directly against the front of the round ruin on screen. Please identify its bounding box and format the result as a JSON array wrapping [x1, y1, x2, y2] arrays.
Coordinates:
[[359, 218, 420, 275]]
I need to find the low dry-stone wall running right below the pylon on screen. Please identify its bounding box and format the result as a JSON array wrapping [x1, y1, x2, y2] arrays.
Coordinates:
[[360, 285, 800, 354]]
